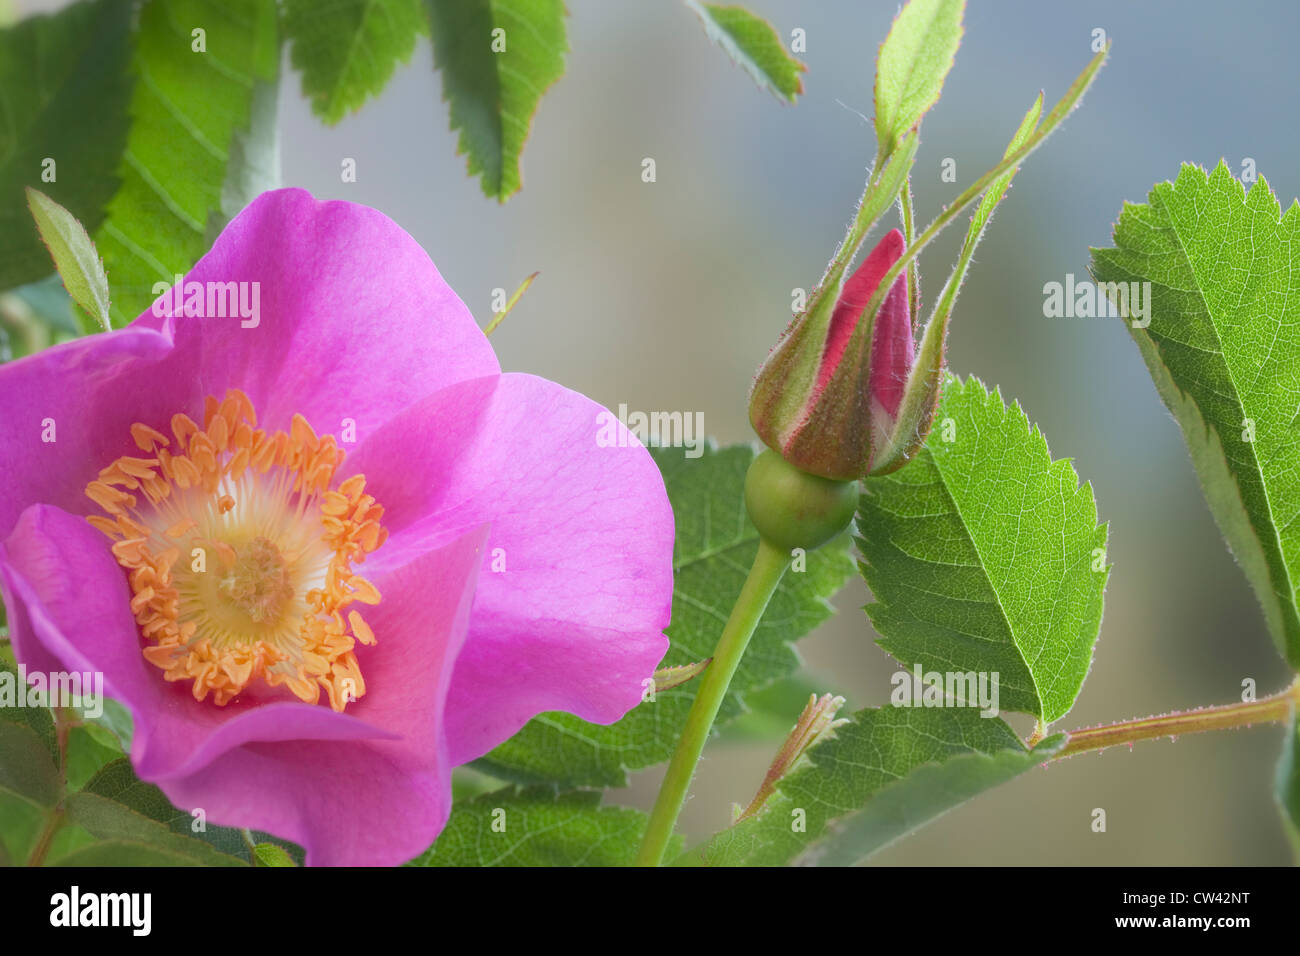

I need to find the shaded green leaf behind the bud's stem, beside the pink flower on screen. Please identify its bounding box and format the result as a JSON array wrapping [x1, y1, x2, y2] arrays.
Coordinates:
[[477, 445, 853, 787]]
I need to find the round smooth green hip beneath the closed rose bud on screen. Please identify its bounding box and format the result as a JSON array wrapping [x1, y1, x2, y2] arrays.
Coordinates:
[[745, 449, 858, 551]]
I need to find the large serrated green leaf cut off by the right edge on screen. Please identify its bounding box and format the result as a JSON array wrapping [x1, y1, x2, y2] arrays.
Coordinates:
[[1092, 163, 1300, 667]]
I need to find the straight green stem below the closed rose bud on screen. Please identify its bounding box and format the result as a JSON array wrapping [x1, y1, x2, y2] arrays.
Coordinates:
[[636, 538, 790, 866]]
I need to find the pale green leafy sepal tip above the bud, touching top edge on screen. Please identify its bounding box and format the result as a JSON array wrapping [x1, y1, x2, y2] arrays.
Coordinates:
[[876, 0, 966, 155]]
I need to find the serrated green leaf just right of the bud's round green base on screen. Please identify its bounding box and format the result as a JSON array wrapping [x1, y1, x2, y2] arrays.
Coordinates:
[[857, 377, 1109, 723]]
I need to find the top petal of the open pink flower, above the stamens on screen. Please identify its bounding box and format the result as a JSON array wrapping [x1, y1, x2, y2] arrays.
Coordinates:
[[140, 189, 501, 436]]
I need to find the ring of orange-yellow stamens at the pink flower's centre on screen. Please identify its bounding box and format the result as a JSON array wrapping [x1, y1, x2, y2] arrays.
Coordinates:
[[86, 389, 387, 710]]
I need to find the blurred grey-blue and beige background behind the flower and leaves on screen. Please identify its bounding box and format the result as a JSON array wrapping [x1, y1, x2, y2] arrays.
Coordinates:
[[17, 0, 1300, 865]]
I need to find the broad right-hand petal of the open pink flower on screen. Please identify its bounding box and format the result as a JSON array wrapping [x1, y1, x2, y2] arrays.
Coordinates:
[[345, 375, 673, 763]]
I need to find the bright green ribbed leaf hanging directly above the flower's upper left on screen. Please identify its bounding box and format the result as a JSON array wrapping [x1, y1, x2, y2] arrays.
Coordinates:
[[95, 0, 278, 326]]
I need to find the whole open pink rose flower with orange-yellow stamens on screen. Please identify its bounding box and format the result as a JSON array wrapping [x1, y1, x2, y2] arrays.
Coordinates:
[[0, 190, 673, 865]]
